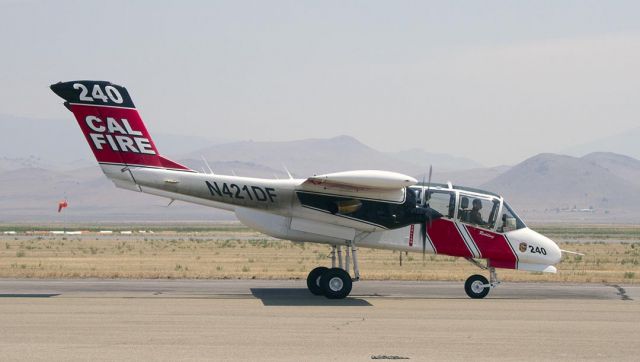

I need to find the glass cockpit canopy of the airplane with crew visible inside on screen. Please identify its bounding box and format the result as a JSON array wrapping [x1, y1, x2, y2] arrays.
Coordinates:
[[411, 184, 526, 233]]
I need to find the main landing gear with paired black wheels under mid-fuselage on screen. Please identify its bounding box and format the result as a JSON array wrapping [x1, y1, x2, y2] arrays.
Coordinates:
[[307, 242, 360, 299]]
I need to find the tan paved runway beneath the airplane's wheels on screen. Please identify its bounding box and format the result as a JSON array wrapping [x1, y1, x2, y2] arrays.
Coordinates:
[[0, 279, 640, 361]]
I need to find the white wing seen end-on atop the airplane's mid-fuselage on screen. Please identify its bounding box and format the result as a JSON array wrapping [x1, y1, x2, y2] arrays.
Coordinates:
[[300, 170, 418, 202]]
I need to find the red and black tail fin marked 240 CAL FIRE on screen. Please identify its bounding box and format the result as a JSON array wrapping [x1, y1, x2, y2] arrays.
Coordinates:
[[51, 80, 195, 172]]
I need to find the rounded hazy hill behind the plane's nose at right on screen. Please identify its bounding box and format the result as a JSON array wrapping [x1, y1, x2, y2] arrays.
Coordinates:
[[481, 153, 640, 222]]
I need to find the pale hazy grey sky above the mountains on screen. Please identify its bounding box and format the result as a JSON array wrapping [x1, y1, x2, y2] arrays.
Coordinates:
[[0, 0, 640, 165]]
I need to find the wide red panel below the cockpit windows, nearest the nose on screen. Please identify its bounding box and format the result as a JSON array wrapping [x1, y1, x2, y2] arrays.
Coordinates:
[[464, 225, 518, 269]]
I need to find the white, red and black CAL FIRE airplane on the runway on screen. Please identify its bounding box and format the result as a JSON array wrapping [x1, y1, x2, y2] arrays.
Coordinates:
[[51, 80, 563, 299]]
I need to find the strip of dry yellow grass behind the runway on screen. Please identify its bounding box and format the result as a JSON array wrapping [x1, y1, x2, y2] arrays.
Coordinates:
[[0, 227, 640, 283]]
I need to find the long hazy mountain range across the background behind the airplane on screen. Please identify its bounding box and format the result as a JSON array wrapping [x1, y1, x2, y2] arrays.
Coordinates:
[[5, 117, 640, 222]]
